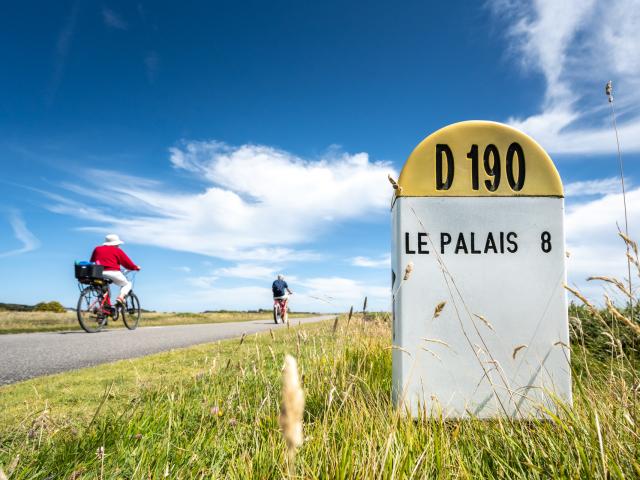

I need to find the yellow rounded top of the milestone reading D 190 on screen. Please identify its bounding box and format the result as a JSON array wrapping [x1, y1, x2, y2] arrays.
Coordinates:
[[396, 120, 564, 197]]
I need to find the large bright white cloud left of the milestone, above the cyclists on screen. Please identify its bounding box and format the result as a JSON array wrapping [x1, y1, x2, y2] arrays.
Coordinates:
[[47, 142, 395, 262]]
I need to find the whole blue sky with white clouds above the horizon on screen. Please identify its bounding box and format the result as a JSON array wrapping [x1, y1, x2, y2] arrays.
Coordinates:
[[0, 0, 640, 311]]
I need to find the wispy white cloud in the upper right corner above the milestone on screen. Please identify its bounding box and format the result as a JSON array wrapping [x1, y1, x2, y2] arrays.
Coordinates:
[[489, 0, 640, 154]]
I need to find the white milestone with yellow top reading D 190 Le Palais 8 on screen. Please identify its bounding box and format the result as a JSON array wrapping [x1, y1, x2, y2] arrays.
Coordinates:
[[392, 121, 572, 418]]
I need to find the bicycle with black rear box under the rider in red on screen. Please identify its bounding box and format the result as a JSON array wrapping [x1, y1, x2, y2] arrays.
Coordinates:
[[76, 271, 140, 333]]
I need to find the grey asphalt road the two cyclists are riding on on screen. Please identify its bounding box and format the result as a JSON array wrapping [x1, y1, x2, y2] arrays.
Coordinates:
[[0, 315, 334, 385]]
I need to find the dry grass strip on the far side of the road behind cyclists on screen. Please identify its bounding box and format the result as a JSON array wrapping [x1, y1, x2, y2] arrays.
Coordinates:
[[0, 311, 313, 334]]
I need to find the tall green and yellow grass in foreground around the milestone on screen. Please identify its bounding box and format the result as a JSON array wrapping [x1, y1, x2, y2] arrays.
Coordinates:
[[0, 307, 640, 479]]
